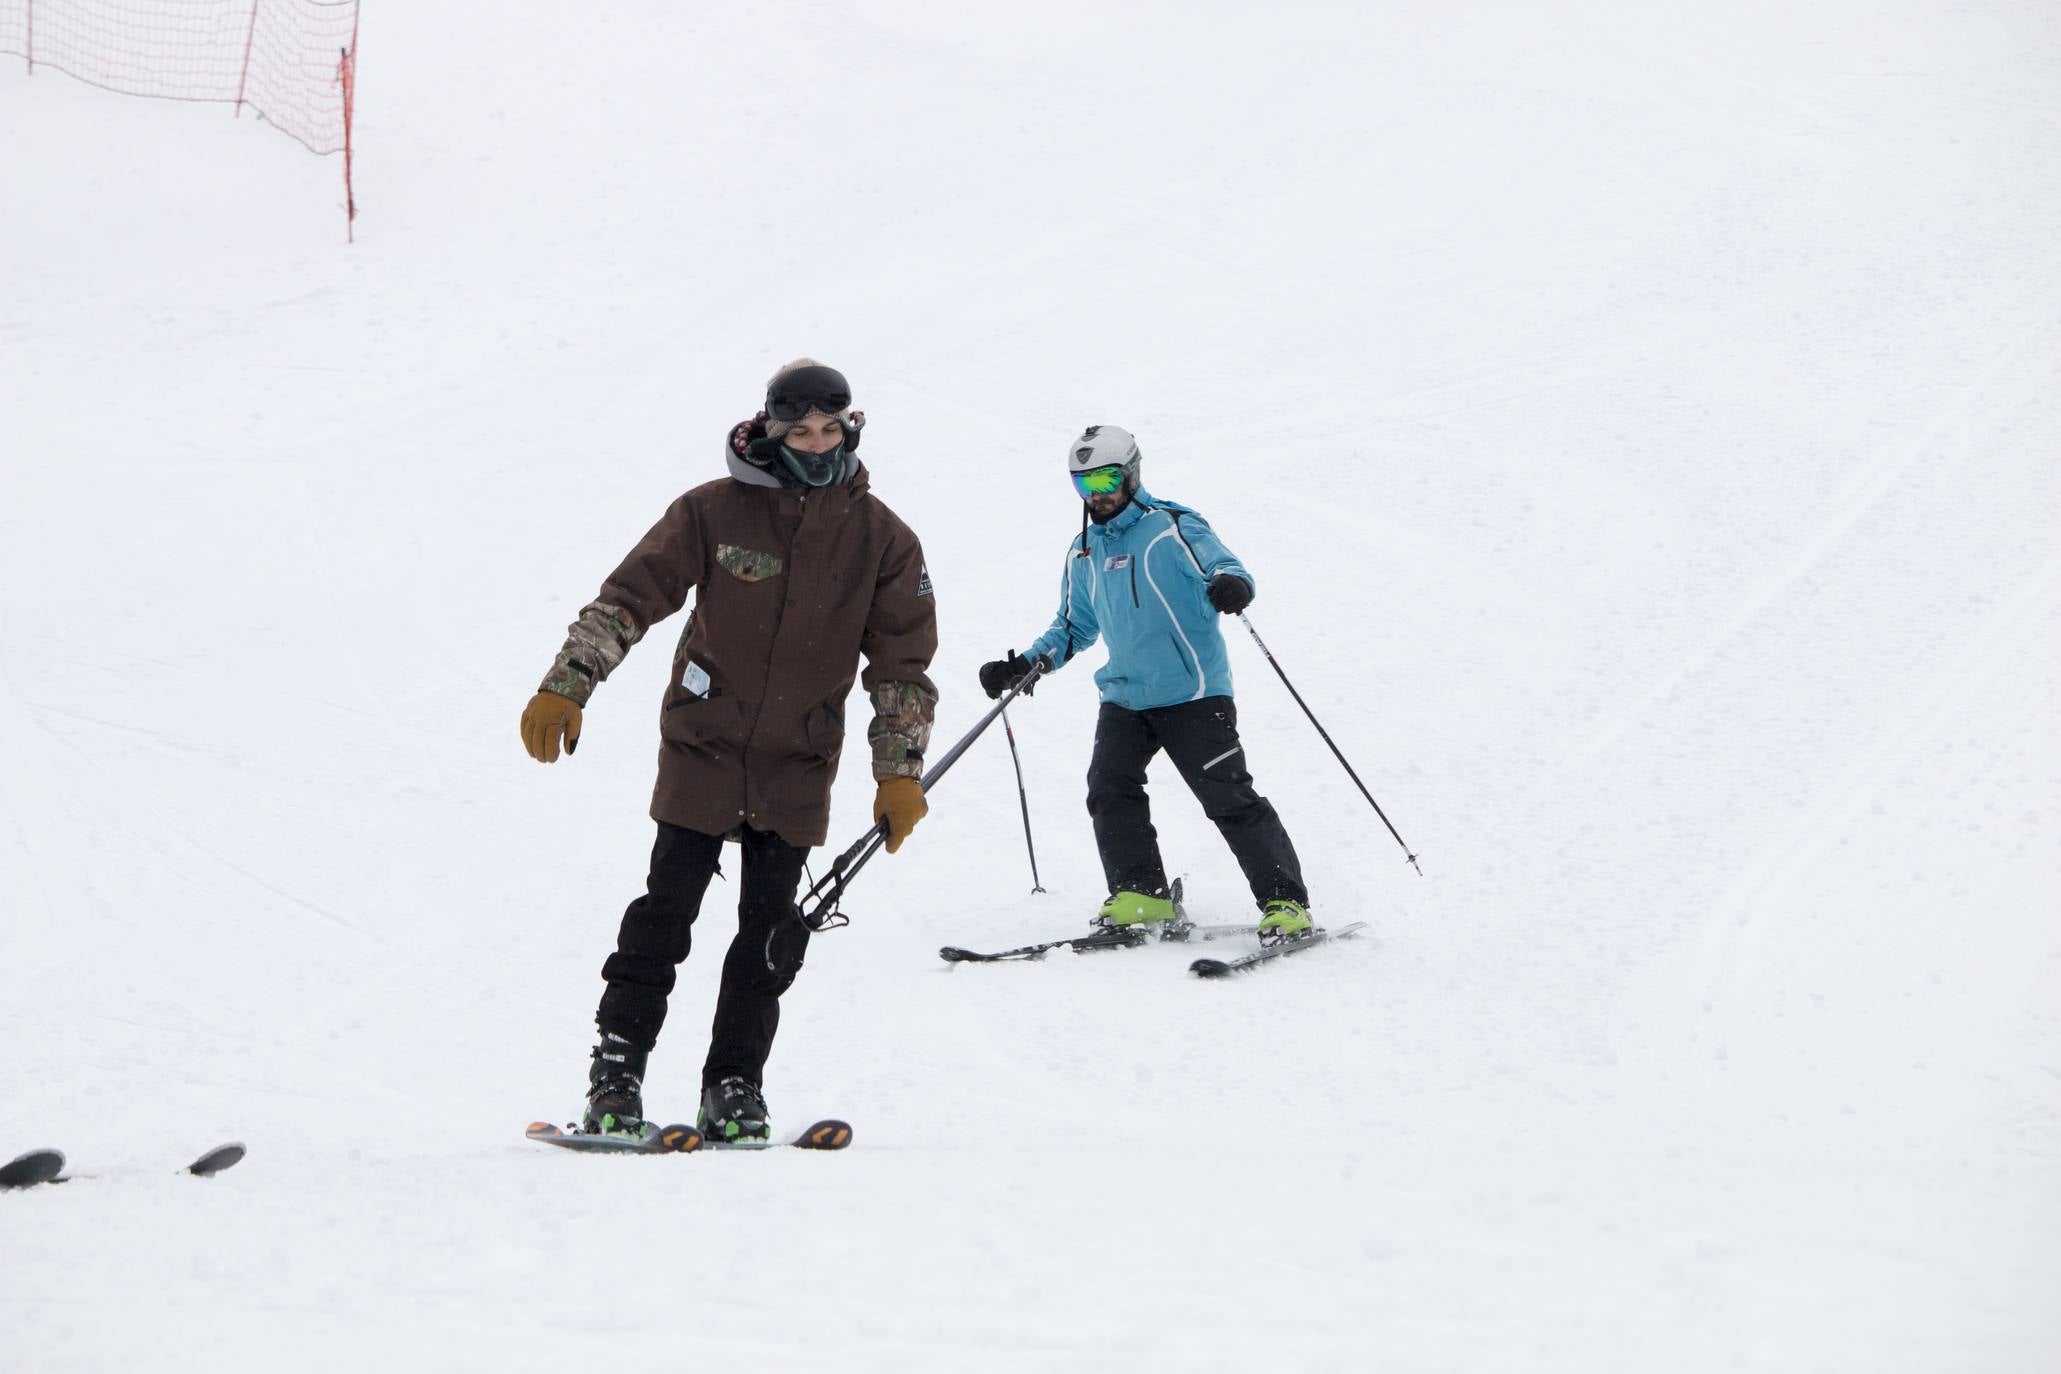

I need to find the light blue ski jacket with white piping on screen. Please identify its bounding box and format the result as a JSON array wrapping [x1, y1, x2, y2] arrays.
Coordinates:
[[1024, 488, 1255, 711]]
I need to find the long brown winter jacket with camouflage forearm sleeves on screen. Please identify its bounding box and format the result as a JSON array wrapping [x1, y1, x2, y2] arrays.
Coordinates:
[[544, 459, 938, 847]]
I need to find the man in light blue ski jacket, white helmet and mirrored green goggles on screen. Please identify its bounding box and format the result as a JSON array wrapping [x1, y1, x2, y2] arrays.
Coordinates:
[[981, 424, 1311, 943]]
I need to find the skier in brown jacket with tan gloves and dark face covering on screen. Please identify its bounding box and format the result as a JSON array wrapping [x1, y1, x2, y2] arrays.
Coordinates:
[[521, 358, 938, 1141]]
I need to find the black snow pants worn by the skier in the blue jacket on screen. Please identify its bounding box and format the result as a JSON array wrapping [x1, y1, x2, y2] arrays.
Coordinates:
[[1088, 696, 1309, 906]]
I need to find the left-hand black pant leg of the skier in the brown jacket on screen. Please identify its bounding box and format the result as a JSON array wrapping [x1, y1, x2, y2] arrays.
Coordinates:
[[594, 822, 723, 1051]]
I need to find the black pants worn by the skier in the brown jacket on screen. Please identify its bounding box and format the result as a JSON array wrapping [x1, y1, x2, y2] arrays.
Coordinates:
[[594, 822, 808, 1088]]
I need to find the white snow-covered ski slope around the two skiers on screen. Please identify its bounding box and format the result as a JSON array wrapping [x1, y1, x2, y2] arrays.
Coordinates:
[[0, 0, 2061, 1374]]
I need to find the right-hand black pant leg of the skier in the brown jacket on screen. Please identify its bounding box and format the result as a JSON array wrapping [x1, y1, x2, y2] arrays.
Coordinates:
[[701, 828, 808, 1088]]
